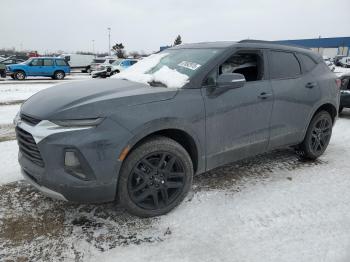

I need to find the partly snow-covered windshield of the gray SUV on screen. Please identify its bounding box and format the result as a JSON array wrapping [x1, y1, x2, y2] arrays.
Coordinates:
[[114, 48, 220, 88]]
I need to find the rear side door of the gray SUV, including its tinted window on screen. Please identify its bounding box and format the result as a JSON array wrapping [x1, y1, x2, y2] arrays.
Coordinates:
[[269, 50, 320, 149]]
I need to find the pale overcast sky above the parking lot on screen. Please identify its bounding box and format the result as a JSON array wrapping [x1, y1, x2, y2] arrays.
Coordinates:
[[0, 0, 350, 53]]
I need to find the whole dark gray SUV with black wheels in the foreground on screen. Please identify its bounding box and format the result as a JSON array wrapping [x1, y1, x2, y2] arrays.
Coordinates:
[[15, 40, 339, 217]]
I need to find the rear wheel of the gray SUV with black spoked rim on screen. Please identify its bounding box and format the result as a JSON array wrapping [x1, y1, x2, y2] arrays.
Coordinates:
[[298, 111, 333, 160]]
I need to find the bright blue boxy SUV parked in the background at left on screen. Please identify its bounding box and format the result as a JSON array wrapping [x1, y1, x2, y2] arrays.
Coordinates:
[[7, 57, 70, 80]]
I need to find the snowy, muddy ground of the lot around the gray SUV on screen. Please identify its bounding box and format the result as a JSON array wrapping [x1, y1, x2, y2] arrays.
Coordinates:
[[0, 68, 350, 262]]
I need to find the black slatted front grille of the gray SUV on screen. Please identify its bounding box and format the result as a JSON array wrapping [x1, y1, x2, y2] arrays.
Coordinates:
[[16, 127, 44, 167]]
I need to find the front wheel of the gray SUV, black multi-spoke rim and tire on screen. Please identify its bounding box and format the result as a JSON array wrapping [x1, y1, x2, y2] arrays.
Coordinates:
[[118, 136, 193, 217]]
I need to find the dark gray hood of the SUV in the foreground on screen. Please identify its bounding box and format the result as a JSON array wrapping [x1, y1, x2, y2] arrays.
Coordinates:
[[21, 79, 177, 120]]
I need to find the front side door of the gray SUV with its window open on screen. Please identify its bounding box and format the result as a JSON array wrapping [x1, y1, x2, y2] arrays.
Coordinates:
[[202, 50, 273, 169]]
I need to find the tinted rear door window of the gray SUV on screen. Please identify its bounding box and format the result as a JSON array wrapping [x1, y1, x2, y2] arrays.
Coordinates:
[[270, 51, 301, 79]]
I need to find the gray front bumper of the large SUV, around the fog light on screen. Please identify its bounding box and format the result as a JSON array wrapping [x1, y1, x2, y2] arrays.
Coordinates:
[[18, 119, 131, 203]]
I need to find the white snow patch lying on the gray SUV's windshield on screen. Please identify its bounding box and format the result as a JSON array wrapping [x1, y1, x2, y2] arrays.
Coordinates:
[[112, 53, 188, 88]]
